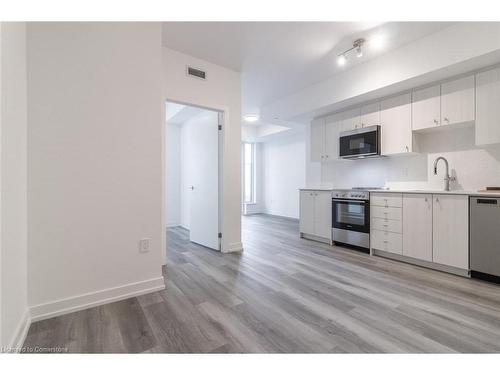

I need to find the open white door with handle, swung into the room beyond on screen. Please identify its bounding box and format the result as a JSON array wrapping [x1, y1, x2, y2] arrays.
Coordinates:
[[185, 110, 219, 250]]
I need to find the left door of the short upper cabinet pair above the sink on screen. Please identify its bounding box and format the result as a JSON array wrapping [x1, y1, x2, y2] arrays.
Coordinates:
[[411, 85, 441, 130]]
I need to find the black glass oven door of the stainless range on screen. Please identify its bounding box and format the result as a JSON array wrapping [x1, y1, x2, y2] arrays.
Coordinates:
[[332, 198, 370, 233]]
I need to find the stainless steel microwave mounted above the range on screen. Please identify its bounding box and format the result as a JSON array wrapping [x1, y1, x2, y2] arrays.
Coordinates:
[[339, 125, 380, 159]]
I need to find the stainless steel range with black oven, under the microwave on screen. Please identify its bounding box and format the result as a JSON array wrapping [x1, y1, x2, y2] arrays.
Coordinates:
[[332, 187, 382, 253]]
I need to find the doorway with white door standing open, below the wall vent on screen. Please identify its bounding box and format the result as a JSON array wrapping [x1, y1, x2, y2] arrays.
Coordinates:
[[164, 101, 223, 251]]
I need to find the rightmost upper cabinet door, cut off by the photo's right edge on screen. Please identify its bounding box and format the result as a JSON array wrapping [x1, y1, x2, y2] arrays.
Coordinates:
[[476, 68, 500, 145]]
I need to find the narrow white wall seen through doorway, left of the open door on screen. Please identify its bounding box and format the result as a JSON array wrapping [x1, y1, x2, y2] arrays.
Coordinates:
[[165, 124, 181, 227]]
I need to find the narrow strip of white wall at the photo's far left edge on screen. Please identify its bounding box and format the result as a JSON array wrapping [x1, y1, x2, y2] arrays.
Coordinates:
[[0, 23, 29, 347]]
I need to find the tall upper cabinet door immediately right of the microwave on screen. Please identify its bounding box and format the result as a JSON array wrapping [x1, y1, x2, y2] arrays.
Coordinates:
[[380, 93, 412, 155]]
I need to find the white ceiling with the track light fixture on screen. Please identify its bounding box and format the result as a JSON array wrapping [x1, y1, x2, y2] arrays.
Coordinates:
[[162, 22, 451, 141]]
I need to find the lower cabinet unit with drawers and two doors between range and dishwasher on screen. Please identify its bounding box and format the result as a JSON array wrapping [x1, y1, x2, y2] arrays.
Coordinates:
[[370, 192, 469, 276]]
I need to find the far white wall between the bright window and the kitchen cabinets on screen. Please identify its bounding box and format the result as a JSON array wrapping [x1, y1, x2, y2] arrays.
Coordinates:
[[262, 132, 306, 218]]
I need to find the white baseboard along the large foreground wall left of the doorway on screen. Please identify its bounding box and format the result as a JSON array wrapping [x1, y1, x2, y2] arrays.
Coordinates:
[[30, 276, 165, 322]]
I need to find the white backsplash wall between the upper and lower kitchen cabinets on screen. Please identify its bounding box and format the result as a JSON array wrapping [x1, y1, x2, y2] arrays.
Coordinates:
[[312, 127, 500, 191]]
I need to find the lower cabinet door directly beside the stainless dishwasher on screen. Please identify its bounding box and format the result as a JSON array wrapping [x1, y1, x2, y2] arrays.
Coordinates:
[[432, 194, 469, 269]]
